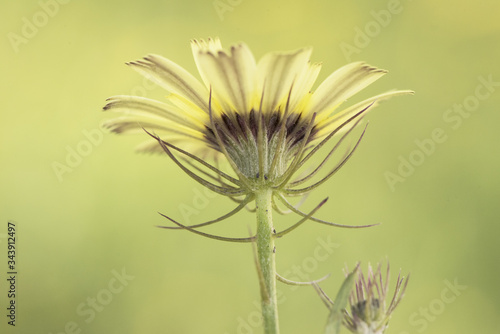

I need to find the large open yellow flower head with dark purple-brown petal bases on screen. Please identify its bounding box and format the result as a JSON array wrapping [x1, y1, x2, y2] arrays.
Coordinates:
[[104, 39, 412, 235]]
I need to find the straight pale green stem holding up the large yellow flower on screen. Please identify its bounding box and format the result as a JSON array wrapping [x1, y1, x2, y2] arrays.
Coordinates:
[[255, 188, 279, 334]]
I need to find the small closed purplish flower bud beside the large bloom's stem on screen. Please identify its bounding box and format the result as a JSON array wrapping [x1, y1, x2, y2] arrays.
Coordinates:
[[344, 264, 408, 334]]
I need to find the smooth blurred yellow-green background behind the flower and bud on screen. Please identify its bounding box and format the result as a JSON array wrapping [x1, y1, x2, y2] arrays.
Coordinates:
[[0, 0, 500, 334]]
